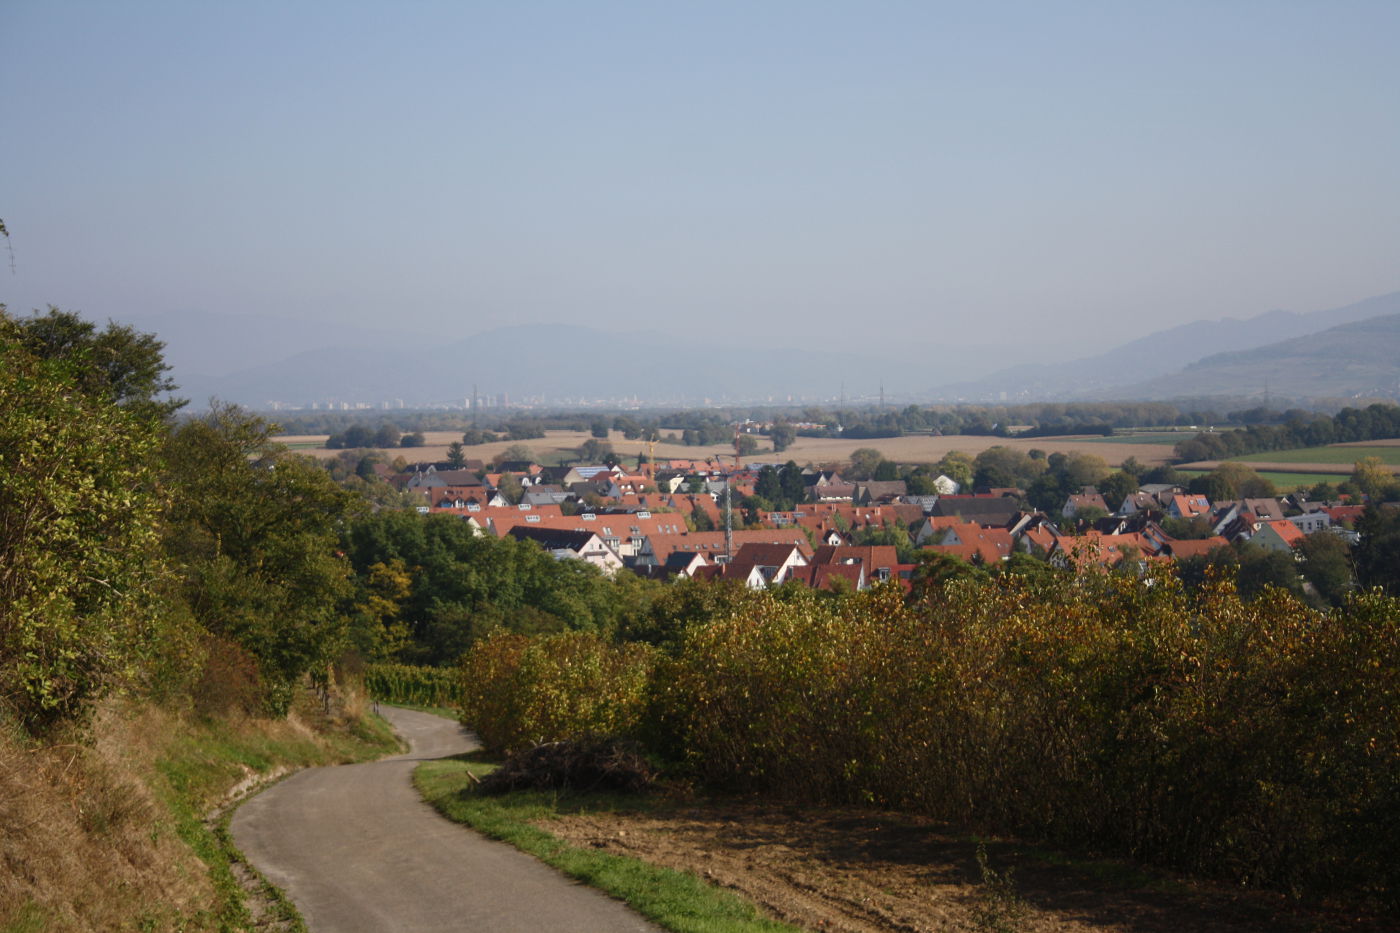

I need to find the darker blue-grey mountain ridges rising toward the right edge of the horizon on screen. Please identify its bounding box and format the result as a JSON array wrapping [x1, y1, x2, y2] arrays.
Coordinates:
[[930, 291, 1400, 402]]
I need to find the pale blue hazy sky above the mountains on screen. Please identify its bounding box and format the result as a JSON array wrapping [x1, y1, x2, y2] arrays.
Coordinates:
[[0, 0, 1400, 349]]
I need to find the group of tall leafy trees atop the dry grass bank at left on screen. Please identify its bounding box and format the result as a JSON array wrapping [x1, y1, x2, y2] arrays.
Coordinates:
[[0, 310, 417, 735]]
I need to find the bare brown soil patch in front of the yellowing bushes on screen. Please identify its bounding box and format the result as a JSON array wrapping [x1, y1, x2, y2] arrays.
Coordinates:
[[539, 806, 1386, 933]]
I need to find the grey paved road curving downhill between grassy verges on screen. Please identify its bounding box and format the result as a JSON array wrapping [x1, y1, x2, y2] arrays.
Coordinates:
[[231, 706, 657, 933]]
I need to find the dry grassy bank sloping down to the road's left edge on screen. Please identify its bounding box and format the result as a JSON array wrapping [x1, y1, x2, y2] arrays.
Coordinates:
[[0, 675, 392, 933]]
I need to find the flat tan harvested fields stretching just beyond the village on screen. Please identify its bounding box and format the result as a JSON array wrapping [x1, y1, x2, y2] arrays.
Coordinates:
[[277, 431, 1172, 465]]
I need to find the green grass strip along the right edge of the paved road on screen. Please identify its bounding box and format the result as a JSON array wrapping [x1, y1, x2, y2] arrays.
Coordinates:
[[414, 755, 797, 933]]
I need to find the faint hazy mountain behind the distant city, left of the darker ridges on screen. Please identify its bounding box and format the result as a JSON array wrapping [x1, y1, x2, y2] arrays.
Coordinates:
[[171, 325, 946, 408]]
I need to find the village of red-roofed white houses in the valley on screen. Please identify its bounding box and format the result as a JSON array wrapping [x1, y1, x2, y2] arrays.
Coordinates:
[[374, 445, 1364, 591]]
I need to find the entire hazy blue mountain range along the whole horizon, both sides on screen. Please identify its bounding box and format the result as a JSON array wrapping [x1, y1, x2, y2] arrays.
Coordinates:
[[123, 291, 1400, 409]]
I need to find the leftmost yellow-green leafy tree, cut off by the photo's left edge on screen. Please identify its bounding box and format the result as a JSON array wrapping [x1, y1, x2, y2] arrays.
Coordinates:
[[0, 323, 171, 733]]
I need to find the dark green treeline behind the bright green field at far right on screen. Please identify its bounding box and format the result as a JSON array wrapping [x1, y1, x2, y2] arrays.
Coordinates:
[[1175, 402, 1400, 462]]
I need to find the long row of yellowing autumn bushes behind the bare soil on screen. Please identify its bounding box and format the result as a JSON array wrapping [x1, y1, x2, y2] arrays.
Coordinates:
[[462, 570, 1400, 906]]
